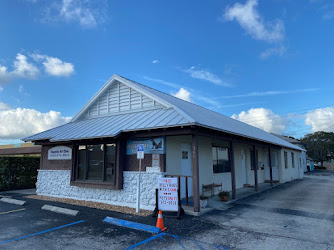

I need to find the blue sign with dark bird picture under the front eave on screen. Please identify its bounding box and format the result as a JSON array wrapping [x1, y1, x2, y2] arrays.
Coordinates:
[[126, 137, 165, 155]]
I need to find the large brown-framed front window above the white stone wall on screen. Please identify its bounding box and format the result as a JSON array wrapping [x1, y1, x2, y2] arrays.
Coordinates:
[[76, 144, 116, 183]]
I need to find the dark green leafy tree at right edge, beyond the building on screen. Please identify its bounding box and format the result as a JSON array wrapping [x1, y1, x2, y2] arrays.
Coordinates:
[[301, 131, 334, 167]]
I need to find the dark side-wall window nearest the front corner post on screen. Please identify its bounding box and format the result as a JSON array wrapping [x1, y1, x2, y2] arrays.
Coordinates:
[[212, 147, 231, 173]]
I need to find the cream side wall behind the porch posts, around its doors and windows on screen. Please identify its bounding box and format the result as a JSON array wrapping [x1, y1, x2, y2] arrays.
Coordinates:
[[166, 136, 304, 197]]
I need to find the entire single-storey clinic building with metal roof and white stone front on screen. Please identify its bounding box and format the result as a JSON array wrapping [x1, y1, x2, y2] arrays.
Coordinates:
[[24, 75, 304, 212]]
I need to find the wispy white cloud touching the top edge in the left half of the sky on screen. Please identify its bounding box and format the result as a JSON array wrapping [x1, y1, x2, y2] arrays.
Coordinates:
[[42, 0, 107, 29]]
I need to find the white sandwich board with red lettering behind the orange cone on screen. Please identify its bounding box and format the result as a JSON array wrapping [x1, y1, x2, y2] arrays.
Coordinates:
[[158, 178, 178, 212]]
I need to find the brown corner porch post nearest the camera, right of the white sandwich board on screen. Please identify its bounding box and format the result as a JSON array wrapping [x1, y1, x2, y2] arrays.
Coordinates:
[[191, 134, 200, 212]]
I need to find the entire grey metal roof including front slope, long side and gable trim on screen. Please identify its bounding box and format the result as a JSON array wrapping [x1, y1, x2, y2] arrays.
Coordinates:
[[23, 75, 303, 150]]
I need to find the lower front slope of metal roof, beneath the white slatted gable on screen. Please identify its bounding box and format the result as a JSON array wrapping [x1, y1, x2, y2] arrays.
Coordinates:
[[24, 108, 189, 141]]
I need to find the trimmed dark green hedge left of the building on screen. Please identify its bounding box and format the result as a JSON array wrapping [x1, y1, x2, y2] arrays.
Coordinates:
[[0, 157, 40, 191]]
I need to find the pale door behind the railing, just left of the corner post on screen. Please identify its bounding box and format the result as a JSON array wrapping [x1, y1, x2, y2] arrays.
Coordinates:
[[181, 143, 193, 199]]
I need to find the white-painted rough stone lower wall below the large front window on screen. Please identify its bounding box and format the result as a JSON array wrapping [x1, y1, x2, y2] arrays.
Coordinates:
[[36, 170, 164, 210]]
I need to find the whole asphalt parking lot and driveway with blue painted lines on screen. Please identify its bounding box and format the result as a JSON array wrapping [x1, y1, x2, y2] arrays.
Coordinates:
[[0, 176, 334, 250]]
